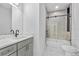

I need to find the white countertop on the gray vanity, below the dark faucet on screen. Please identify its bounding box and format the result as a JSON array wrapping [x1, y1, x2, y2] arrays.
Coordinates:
[[0, 35, 33, 49]]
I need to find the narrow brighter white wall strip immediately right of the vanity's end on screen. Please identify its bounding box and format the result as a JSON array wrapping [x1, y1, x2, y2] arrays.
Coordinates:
[[34, 3, 40, 56]]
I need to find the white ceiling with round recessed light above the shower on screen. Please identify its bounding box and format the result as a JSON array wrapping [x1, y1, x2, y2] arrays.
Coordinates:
[[46, 3, 69, 12]]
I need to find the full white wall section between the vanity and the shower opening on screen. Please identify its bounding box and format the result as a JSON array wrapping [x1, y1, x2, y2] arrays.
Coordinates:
[[34, 3, 46, 56]]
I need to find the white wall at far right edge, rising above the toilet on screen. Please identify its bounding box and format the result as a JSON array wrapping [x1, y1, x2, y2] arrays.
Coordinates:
[[71, 3, 79, 48]]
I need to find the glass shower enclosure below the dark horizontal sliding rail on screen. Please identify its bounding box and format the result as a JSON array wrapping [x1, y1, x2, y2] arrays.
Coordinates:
[[47, 15, 68, 39]]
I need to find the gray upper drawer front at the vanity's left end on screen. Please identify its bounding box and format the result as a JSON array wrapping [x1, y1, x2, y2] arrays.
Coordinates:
[[0, 45, 16, 56]]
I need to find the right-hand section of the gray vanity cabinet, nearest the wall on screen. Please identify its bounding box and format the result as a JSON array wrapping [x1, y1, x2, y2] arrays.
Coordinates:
[[18, 38, 33, 56]]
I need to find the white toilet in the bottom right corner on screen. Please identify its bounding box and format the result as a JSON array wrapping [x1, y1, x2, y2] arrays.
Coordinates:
[[62, 45, 79, 56]]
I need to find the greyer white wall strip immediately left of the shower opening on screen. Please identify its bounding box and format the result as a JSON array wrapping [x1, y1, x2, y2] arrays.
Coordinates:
[[39, 3, 46, 54]]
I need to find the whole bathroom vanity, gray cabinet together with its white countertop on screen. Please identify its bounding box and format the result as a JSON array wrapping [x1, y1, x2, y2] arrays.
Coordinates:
[[0, 36, 33, 56]]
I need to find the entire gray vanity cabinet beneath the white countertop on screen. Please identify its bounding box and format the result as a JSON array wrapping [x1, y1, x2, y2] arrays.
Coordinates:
[[0, 38, 33, 56]]
